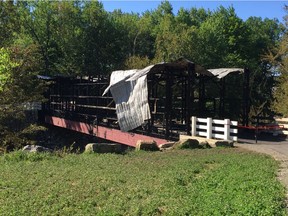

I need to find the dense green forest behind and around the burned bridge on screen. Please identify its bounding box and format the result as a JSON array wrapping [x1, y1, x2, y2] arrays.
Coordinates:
[[0, 0, 288, 150]]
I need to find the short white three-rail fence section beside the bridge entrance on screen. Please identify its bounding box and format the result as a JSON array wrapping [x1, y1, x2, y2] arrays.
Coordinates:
[[191, 116, 238, 142]]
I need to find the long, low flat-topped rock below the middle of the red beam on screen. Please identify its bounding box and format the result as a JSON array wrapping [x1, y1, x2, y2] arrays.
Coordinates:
[[85, 143, 122, 153]]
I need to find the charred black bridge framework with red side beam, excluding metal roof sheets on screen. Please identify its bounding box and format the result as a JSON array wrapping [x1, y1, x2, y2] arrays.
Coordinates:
[[42, 60, 249, 146]]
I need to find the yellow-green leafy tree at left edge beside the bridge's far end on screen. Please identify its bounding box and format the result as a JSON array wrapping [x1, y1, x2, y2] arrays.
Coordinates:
[[0, 46, 45, 150]]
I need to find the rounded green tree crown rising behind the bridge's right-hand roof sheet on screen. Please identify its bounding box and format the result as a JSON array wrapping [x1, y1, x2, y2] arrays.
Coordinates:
[[197, 6, 247, 68]]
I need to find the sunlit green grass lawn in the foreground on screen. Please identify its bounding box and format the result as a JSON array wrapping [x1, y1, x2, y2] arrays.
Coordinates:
[[0, 148, 285, 216]]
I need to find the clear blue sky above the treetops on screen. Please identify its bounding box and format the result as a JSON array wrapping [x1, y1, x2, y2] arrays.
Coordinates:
[[101, 0, 288, 22]]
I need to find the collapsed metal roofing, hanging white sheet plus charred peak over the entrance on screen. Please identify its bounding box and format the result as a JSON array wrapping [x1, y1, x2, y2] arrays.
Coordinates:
[[103, 58, 214, 131]]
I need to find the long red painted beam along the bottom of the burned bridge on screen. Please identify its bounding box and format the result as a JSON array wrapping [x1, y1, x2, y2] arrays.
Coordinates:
[[45, 116, 169, 147]]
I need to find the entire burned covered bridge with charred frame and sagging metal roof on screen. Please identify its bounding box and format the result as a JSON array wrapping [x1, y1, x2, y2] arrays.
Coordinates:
[[40, 59, 249, 146]]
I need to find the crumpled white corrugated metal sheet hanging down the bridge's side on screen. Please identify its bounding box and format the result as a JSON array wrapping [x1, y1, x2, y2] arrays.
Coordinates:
[[103, 69, 152, 131]]
